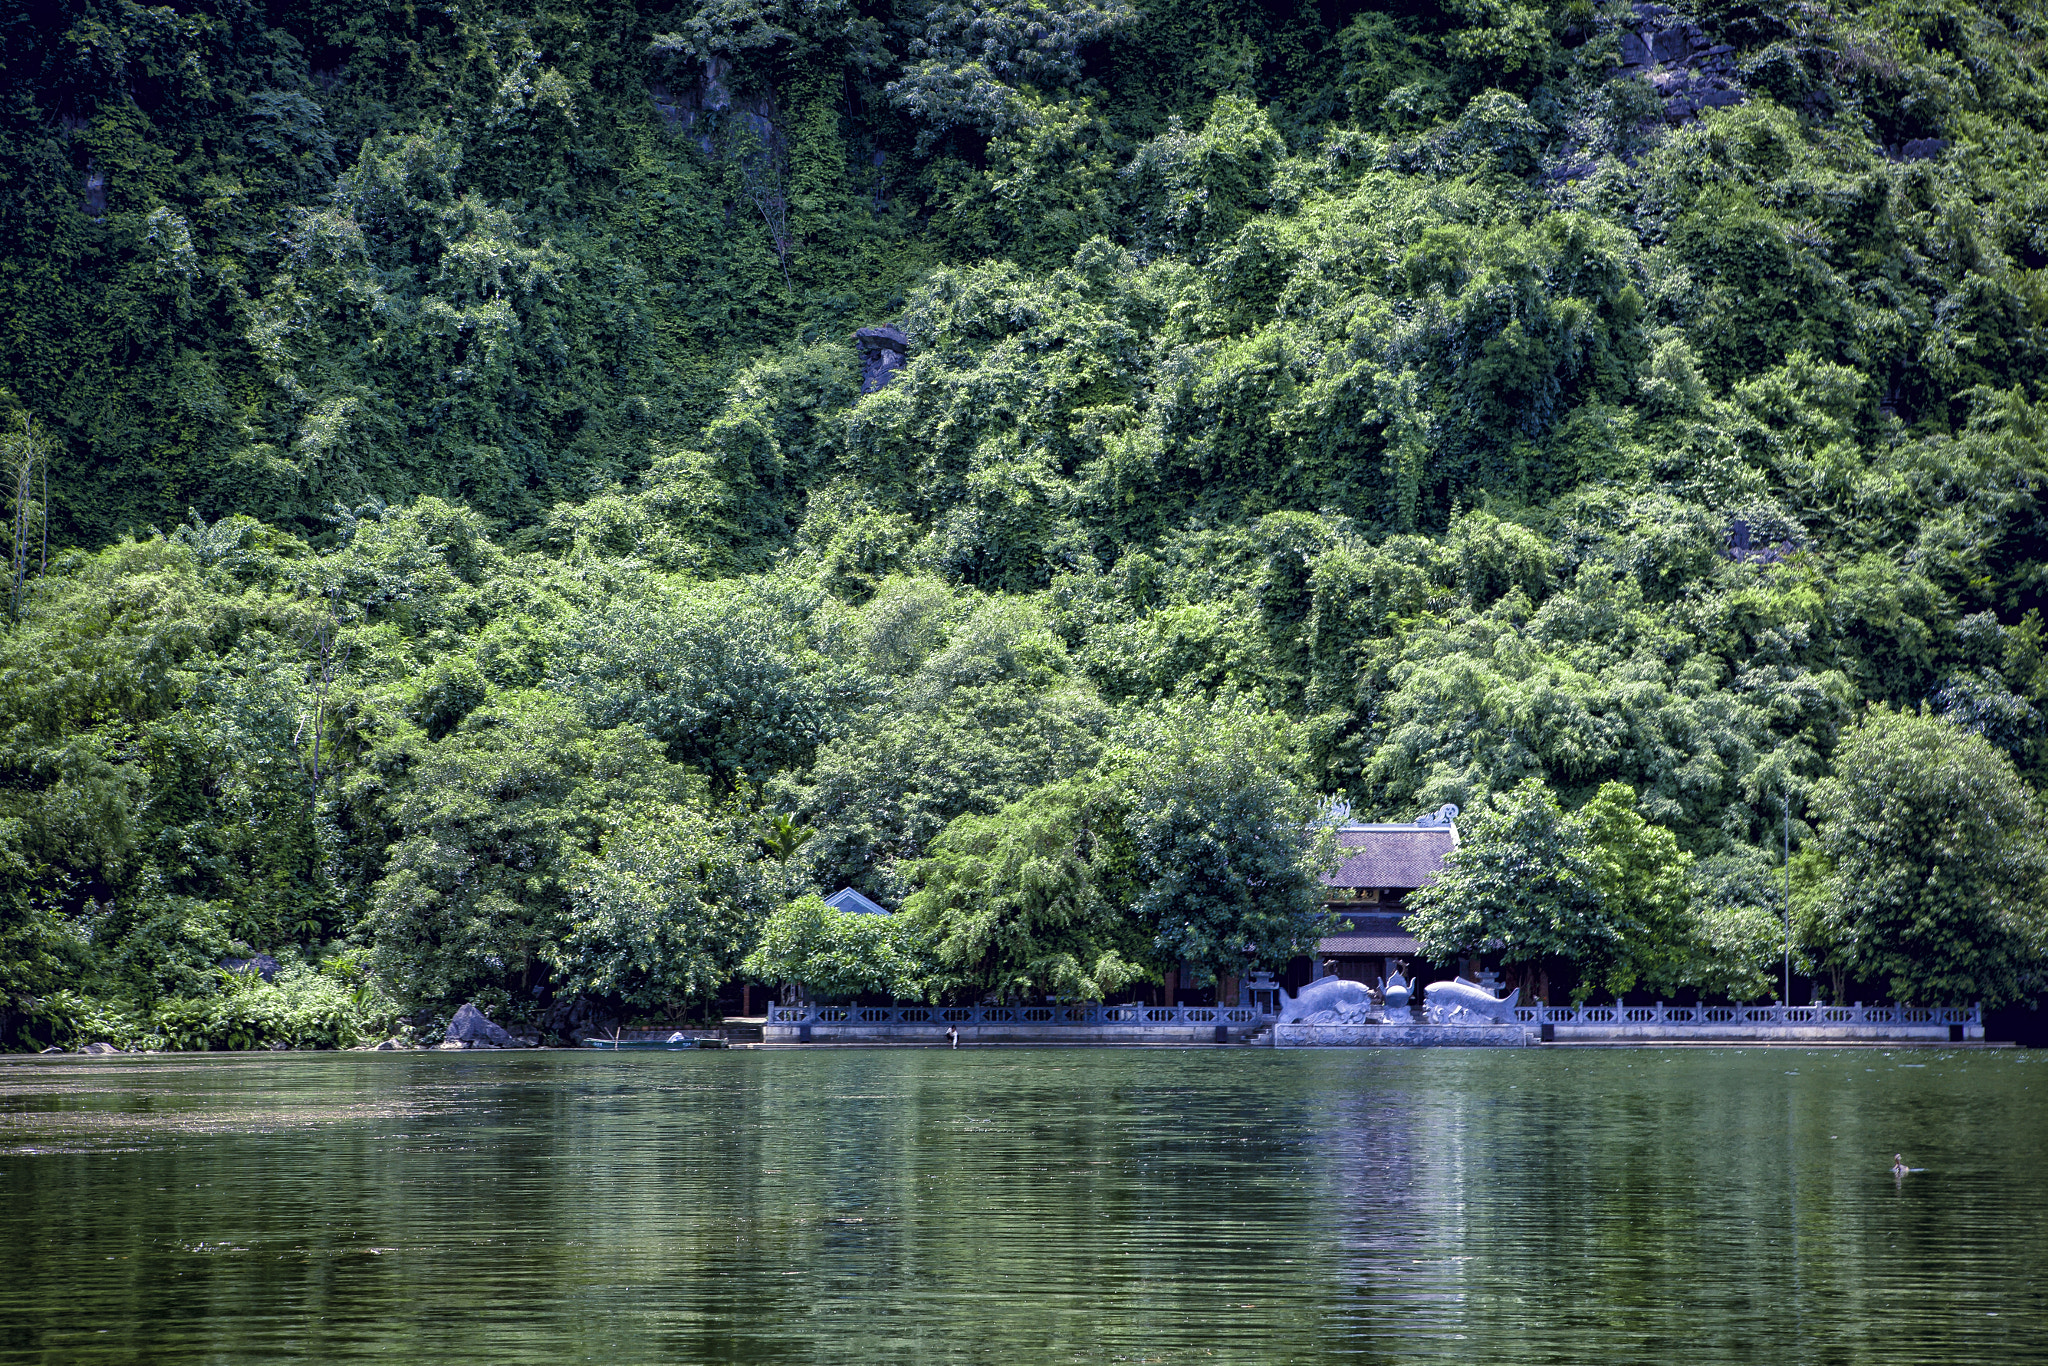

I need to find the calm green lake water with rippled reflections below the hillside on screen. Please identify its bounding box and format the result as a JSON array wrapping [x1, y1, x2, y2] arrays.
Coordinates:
[[0, 1049, 2048, 1366]]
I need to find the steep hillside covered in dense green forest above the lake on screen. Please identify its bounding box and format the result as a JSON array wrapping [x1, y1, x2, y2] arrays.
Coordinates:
[[0, 0, 2048, 1047]]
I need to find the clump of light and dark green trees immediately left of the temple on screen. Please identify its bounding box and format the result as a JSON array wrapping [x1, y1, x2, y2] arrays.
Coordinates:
[[903, 705, 1333, 1001]]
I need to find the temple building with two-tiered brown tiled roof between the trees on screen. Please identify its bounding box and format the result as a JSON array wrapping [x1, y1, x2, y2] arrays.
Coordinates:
[[1284, 805, 1458, 991]]
